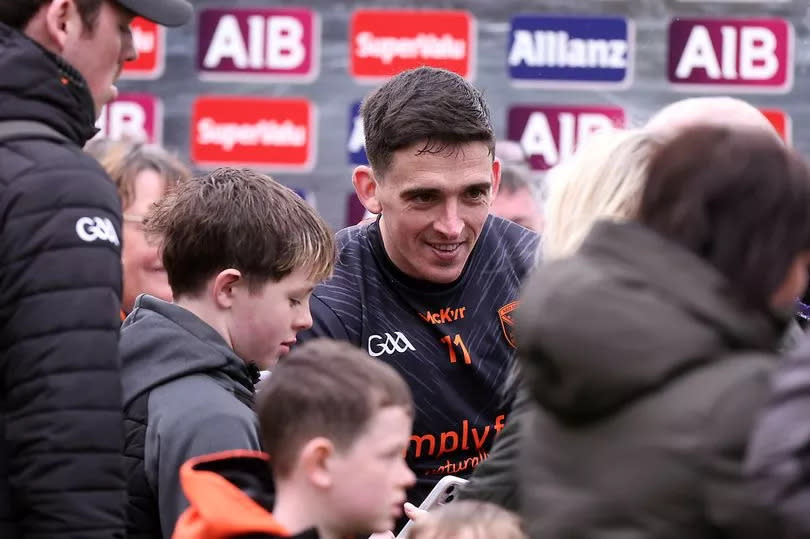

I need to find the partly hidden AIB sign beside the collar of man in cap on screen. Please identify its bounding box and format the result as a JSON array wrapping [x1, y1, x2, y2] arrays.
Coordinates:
[[96, 93, 163, 144]]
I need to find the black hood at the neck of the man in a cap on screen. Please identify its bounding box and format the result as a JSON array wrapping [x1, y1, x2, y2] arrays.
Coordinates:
[[0, 23, 98, 146]]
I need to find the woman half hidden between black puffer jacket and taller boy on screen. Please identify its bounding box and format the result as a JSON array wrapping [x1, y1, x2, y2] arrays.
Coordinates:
[[85, 138, 191, 319]]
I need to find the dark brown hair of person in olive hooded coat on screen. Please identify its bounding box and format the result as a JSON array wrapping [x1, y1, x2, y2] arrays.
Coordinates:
[[639, 126, 810, 309]]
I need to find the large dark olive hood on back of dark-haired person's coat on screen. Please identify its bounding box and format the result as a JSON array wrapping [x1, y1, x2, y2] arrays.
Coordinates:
[[516, 222, 788, 423]]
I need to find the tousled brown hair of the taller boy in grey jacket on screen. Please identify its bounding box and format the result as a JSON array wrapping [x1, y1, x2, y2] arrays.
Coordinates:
[[144, 168, 335, 297]]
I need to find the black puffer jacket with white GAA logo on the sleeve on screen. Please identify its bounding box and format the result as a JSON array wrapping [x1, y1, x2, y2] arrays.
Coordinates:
[[0, 25, 126, 539]]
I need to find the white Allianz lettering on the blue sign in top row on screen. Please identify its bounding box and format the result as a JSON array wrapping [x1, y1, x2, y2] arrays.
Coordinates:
[[509, 30, 628, 69]]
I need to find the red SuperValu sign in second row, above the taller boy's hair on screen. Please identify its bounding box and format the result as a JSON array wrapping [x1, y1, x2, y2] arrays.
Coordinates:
[[191, 96, 315, 171]]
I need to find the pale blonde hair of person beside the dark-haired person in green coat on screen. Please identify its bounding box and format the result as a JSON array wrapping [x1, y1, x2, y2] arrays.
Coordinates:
[[540, 129, 660, 260]]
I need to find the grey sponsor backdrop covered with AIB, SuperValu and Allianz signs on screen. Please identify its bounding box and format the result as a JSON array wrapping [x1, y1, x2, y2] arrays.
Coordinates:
[[112, 0, 810, 228]]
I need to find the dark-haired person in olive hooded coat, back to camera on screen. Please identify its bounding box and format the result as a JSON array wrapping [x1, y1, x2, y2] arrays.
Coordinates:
[[516, 127, 810, 539]]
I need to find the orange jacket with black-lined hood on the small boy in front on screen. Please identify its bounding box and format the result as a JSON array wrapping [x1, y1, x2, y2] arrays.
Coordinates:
[[172, 450, 296, 539]]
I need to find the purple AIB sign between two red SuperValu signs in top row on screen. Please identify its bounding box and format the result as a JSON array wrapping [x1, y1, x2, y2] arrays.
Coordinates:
[[197, 8, 320, 82]]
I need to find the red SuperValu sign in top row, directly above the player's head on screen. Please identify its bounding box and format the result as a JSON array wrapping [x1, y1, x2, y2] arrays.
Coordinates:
[[349, 9, 475, 81]]
